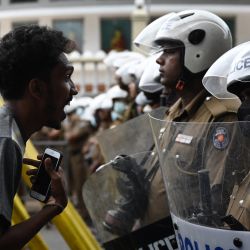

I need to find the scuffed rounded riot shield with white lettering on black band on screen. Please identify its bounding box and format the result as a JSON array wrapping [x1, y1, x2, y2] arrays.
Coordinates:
[[83, 151, 177, 250]]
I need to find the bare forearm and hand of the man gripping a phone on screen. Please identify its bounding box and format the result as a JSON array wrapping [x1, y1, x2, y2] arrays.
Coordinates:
[[0, 159, 68, 250]]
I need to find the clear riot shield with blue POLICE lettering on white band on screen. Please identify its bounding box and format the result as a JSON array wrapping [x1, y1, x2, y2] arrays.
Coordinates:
[[150, 117, 250, 250]]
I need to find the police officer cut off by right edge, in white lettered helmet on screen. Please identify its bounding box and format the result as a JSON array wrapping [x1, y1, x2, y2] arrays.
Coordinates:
[[203, 42, 250, 230]]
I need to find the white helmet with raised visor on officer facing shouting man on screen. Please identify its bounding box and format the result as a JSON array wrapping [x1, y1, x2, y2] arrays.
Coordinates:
[[135, 10, 232, 74]]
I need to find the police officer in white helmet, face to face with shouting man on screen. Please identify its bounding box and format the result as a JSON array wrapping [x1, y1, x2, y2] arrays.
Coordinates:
[[135, 10, 242, 224]]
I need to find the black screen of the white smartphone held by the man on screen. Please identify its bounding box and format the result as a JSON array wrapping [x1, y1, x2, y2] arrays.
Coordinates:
[[32, 154, 58, 196]]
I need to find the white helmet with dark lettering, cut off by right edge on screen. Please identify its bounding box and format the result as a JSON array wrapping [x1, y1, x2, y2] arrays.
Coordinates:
[[202, 42, 250, 99]]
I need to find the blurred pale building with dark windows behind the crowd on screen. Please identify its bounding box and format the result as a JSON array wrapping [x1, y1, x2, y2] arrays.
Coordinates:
[[0, 0, 250, 92]]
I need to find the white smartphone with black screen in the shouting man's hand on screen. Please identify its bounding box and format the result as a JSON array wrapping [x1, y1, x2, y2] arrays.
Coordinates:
[[30, 148, 63, 202]]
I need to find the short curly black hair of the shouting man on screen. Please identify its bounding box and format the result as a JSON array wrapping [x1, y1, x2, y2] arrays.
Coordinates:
[[0, 25, 74, 100]]
